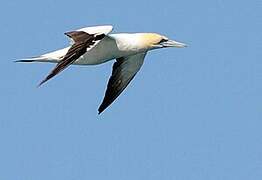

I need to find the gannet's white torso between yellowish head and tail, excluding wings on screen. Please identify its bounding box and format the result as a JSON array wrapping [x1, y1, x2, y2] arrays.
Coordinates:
[[41, 33, 151, 65]]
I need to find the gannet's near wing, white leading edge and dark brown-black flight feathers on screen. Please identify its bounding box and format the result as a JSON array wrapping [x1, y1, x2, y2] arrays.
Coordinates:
[[39, 26, 112, 86]]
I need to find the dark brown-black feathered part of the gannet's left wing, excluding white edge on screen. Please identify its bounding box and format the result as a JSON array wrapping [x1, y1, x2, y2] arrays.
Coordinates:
[[39, 31, 105, 86]]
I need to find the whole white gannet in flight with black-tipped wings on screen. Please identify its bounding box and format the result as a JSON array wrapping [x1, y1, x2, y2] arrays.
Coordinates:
[[16, 25, 186, 114]]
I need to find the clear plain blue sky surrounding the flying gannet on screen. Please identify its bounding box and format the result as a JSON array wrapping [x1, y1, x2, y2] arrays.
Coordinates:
[[0, 0, 262, 180]]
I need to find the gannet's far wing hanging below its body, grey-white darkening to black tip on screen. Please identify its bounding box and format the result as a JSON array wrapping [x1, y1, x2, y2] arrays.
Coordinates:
[[98, 52, 146, 114]]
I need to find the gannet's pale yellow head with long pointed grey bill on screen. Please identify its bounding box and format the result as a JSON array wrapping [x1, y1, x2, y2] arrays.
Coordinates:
[[138, 33, 187, 49]]
